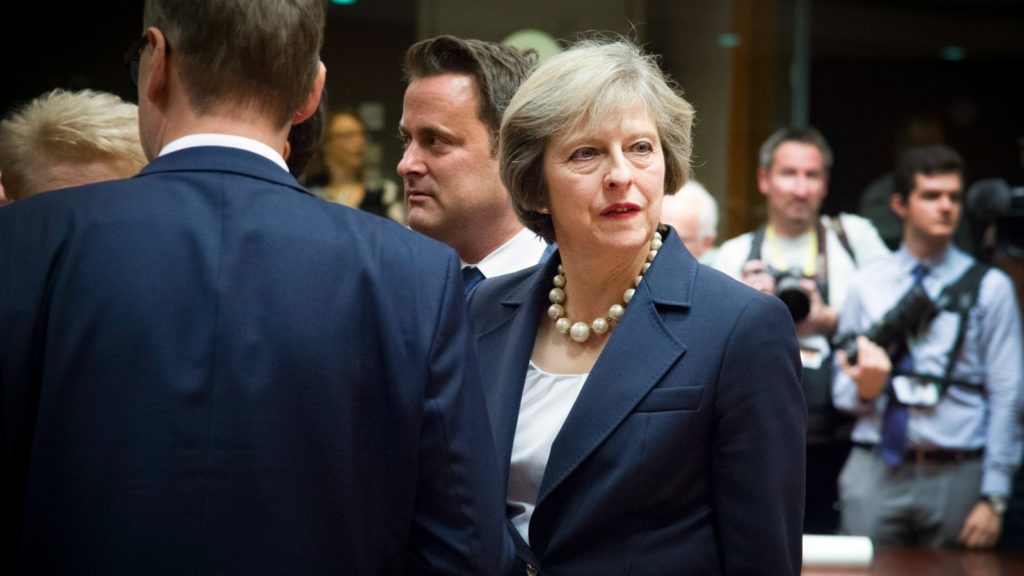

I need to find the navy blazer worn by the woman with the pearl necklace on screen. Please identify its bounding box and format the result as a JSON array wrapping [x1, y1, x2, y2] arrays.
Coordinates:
[[469, 229, 806, 576]]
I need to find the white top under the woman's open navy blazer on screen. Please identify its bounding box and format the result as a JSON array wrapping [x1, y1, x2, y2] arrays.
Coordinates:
[[507, 361, 589, 543]]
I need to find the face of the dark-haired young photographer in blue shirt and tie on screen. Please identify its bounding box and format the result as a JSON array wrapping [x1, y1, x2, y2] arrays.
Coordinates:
[[891, 172, 964, 241]]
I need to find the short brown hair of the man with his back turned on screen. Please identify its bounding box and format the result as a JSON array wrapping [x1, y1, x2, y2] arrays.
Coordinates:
[[142, 0, 326, 126]]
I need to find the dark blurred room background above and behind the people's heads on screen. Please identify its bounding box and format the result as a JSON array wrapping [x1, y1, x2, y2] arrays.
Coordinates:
[[0, 0, 1024, 238]]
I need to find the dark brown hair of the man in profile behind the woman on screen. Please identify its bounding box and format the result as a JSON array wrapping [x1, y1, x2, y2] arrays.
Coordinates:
[[402, 36, 537, 153]]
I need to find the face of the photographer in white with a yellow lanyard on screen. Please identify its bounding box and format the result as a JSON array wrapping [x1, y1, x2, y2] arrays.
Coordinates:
[[758, 141, 828, 234]]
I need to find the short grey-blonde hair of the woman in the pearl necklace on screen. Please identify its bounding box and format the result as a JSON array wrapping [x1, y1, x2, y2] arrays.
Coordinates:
[[499, 38, 693, 242]]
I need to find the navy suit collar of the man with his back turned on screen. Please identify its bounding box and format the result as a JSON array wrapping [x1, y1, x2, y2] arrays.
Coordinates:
[[136, 146, 309, 194]]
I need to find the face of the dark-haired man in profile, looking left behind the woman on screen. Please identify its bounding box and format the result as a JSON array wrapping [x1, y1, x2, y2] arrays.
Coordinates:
[[398, 74, 511, 249]]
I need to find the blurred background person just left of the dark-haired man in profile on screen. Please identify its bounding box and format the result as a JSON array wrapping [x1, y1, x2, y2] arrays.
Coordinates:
[[304, 109, 406, 222]]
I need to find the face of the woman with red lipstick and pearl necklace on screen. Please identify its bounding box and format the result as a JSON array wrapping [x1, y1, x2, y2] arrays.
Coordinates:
[[544, 107, 665, 252]]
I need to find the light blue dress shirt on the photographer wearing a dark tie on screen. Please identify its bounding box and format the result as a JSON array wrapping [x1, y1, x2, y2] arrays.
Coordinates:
[[833, 241, 1024, 494]]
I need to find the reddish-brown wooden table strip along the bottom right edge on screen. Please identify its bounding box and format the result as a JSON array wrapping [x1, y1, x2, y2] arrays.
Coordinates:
[[801, 548, 1024, 576]]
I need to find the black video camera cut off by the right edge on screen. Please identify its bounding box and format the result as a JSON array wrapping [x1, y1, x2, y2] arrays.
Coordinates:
[[965, 178, 1024, 258]]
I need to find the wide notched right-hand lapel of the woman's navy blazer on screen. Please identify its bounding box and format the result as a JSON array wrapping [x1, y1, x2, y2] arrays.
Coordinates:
[[536, 229, 697, 504]]
